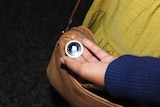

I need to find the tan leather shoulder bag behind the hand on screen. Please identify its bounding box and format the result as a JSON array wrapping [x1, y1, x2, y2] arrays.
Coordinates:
[[47, 26, 121, 107]]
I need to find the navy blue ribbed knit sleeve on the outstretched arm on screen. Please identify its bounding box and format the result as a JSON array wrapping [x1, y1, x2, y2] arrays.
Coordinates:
[[105, 55, 160, 105]]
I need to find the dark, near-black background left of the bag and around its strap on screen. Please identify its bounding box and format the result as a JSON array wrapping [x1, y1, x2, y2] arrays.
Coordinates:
[[0, 0, 92, 107]]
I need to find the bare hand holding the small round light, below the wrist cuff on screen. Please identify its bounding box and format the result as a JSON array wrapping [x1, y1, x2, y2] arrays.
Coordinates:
[[60, 39, 116, 86]]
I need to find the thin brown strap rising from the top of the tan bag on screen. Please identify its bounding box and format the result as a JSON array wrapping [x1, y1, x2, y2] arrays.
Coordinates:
[[62, 0, 81, 33]]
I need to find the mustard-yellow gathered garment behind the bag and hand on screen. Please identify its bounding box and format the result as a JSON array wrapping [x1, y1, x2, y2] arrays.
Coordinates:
[[83, 0, 160, 57]]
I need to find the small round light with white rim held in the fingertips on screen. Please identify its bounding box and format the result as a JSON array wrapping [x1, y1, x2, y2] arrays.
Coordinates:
[[65, 40, 83, 58]]
